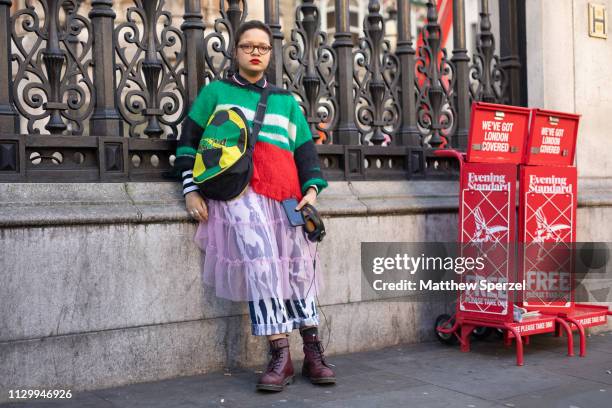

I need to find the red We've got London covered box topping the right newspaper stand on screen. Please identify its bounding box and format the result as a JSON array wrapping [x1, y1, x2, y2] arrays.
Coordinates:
[[525, 109, 580, 166]]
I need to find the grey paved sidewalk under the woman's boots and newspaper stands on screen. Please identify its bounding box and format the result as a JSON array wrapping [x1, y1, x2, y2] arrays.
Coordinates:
[[0, 332, 612, 408]]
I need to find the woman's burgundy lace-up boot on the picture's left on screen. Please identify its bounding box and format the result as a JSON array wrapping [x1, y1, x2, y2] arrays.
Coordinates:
[[256, 338, 294, 391]]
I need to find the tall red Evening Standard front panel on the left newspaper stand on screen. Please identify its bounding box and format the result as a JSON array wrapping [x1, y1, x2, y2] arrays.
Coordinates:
[[457, 163, 517, 322]]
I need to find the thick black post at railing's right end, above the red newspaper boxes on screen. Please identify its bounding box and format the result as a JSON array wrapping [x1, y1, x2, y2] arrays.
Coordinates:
[[499, 0, 521, 105]]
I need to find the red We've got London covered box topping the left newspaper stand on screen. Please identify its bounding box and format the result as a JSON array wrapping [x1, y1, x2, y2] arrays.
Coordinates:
[[467, 102, 530, 164]]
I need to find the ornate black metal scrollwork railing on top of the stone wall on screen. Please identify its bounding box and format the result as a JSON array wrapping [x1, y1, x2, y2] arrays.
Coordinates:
[[0, 0, 521, 182]]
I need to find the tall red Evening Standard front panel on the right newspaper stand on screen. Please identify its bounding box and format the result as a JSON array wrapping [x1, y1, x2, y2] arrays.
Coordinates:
[[519, 166, 577, 312]]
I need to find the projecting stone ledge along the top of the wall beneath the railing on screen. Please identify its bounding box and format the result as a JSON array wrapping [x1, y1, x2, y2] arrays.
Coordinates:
[[0, 178, 612, 228]]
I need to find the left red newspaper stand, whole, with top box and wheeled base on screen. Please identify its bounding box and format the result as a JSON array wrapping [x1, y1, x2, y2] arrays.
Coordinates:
[[435, 103, 572, 366]]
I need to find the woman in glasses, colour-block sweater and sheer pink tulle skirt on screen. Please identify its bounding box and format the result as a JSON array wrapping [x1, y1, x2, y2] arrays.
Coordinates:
[[175, 20, 335, 391]]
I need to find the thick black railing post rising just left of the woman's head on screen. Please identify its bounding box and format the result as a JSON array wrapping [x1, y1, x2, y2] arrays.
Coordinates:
[[181, 0, 204, 106]]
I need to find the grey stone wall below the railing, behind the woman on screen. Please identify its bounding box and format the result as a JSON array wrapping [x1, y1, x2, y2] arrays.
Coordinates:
[[0, 182, 456, 396]]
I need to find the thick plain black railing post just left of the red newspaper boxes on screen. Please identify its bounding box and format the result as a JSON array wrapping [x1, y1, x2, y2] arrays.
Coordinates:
[[451, 0, 470, 149]]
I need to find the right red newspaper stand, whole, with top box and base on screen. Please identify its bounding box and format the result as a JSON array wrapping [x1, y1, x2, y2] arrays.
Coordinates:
[[519, 109, 612, 356]]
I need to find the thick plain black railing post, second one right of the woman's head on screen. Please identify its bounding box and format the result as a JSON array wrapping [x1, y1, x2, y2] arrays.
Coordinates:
[[333, 0, 359, 145]]
